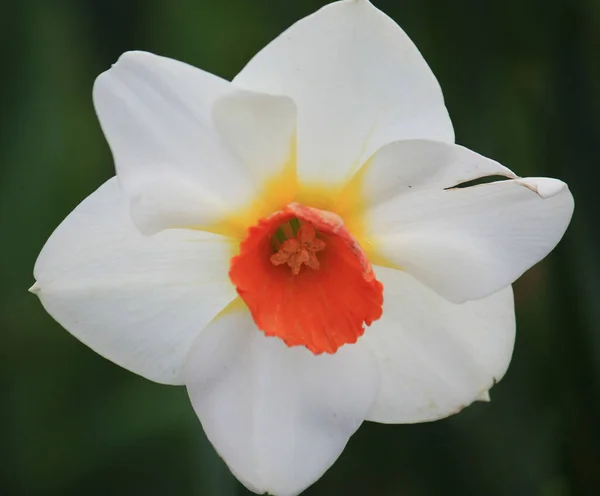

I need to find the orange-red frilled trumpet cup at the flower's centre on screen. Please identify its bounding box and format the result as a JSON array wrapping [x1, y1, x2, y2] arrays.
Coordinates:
[[229, 203, 383, 354]]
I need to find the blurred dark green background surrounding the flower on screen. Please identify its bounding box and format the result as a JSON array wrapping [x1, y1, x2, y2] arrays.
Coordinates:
[[0, 0, 600, 496]]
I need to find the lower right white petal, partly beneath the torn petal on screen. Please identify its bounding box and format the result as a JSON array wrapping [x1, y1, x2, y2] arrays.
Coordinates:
[[363, 267, 515, 423]]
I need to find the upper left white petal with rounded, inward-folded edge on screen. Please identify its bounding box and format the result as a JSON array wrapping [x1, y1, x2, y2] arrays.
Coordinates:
[[93, 52, 254, 232]]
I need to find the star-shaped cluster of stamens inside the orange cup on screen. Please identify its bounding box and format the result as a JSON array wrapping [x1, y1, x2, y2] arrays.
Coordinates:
[[271, 219, 325, 275]]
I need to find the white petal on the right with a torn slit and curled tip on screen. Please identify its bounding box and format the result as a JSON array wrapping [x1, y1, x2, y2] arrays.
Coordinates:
[[357, 141, 574, 303]]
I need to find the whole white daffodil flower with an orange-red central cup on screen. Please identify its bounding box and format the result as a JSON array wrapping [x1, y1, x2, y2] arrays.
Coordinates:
[[32, 0, 573, 495]]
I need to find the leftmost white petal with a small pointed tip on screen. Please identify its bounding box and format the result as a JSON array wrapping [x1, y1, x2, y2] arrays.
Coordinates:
[[32, 178, 236, 384]]
